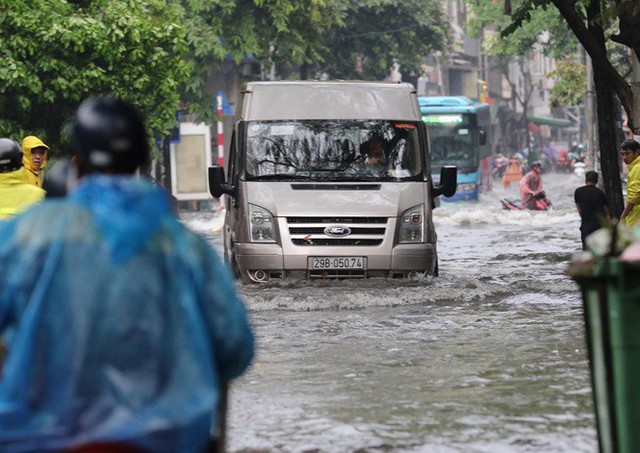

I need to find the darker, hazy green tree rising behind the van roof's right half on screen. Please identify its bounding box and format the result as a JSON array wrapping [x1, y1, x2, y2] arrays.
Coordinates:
[[316, 0, 449, 80]]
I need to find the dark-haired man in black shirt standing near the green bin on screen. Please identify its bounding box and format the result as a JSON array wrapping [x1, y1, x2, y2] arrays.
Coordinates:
[[574, 171, 610, 250]]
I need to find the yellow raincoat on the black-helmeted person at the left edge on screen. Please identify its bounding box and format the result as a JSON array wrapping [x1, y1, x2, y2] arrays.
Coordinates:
[[0, 167, 46, 220]]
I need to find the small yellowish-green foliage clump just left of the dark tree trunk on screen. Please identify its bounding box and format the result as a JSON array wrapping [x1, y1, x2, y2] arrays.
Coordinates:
[[547, 60, 587, 107]]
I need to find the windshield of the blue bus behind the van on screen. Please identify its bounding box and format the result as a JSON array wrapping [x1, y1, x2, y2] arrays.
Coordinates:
[[423, 113, 478, 169]]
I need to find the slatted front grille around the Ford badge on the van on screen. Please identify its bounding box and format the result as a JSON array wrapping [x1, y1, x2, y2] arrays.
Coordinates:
[[287, 217, 387, 247]]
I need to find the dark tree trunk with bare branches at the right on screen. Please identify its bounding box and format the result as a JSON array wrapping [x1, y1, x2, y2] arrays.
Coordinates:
[[504, 0, 640, 216]]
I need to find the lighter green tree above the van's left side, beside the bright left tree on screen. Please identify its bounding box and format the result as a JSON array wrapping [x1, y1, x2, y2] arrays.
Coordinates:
[[173, 0, 341, 122]]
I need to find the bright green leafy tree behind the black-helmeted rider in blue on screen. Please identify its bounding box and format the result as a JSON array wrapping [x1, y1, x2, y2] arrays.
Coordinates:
[[0, 0, 188, 151]]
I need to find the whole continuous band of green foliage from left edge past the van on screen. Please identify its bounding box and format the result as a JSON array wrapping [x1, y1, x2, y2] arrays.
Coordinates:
[[0, 0, 448, 148]]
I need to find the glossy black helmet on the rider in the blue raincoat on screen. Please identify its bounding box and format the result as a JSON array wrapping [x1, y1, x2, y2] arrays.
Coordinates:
[[71, 96, 149, 173]]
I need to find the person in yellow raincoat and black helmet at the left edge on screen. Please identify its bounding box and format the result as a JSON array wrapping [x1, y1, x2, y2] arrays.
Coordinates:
[[0, 138, 45, 224]]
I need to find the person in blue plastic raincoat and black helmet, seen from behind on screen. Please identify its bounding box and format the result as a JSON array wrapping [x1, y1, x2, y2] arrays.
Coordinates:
[[0, 97, 254, 453]]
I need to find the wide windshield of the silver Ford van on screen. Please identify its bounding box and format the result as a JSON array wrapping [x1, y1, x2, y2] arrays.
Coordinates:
[[245, 120, 422, 181]]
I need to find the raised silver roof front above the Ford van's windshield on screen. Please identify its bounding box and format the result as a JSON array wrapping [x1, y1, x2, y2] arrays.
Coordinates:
[[240, 81, 421, 121]]
